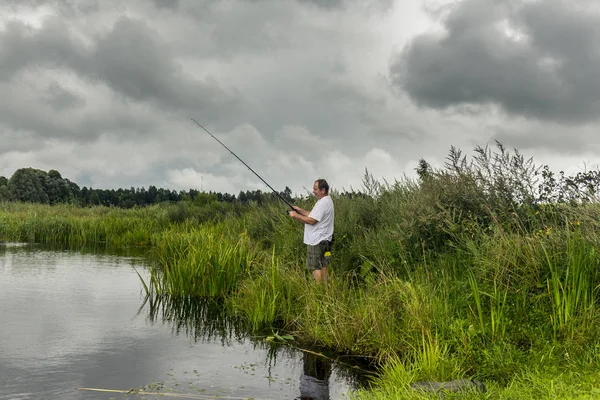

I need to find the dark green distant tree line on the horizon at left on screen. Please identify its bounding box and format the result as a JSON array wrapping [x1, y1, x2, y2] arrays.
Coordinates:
[[0, 168, 293, 208]]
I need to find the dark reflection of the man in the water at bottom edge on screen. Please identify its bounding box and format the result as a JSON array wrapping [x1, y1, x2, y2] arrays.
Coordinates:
[[295, 352, 331, 400]]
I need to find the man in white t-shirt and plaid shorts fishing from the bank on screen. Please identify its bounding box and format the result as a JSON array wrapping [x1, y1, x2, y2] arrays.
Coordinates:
[[289, 179, 334, 282]]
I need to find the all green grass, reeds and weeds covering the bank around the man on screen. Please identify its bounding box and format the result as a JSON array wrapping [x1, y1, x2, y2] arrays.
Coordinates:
[[0, 146, 600, 399]]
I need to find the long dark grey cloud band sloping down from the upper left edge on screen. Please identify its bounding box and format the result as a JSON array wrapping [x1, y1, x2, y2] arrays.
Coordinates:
[[0, 17, 236, 126]]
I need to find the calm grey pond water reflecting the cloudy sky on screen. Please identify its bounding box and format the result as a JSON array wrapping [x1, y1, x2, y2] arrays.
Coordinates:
[[0, 244, 360, 400]]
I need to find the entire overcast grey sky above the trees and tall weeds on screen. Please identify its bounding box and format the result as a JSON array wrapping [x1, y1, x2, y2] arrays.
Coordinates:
[[0, 0, 600, 194]]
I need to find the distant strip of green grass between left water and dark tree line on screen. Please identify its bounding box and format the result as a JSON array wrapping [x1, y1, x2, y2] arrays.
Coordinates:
[[0, 202, 242, 248]]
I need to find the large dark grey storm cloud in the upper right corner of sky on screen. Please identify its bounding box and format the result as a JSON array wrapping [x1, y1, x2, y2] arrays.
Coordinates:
[[390, 0, 600, 123]]
